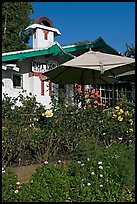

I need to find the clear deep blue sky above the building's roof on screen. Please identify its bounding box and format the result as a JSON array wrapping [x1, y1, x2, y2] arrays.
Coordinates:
[[29, 2, 135, 54]]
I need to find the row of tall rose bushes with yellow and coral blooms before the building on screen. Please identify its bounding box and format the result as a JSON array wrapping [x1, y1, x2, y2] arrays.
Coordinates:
[[2, 90, 135, 166]]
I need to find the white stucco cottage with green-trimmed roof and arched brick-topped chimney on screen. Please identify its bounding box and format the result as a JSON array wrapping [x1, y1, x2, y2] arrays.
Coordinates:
[[2, 17, 134, 108]]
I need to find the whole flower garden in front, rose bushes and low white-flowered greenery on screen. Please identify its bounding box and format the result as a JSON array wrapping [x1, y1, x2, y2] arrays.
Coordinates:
[[2, 89, 135, 202]]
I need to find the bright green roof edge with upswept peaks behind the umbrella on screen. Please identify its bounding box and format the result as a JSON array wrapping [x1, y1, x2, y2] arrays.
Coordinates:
[[2, 37, 120, 62]]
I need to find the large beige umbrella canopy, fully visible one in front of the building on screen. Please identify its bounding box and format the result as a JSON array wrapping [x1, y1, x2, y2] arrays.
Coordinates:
[[44, 51, 135, 85]]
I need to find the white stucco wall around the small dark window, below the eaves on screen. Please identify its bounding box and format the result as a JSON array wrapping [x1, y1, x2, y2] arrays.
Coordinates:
[[2, 60, 51, 108]]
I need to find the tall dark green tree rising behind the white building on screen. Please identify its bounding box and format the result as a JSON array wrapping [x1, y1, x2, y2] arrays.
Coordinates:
[[2, 2, 34, 52]]
